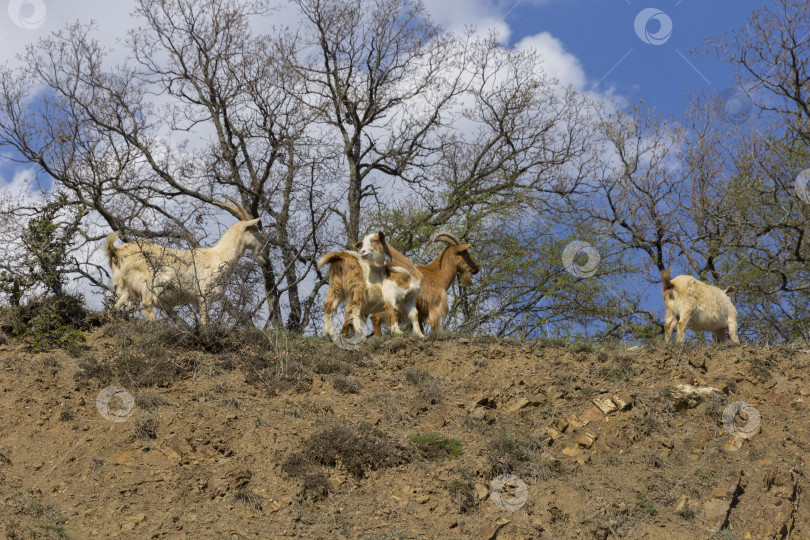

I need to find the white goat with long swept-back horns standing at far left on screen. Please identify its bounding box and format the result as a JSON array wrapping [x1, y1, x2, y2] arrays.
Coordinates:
[[104, 197, 264, 325]]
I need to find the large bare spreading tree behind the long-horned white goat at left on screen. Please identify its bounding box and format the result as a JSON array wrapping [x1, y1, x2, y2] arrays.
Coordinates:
[[0, 0, 331, 329]]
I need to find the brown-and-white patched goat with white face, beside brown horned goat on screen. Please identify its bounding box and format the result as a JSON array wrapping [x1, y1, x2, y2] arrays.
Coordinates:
[[318, 232, 424, 343]]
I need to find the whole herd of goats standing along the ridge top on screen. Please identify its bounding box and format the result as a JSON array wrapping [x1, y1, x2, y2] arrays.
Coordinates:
[[105, 197, 739, 348]]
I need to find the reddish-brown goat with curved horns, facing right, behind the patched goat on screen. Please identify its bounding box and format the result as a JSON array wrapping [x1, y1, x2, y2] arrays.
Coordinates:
[[342, 232, 480, 336]]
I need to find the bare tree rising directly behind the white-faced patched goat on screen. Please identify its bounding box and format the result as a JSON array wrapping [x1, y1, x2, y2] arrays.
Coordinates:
[[287, 0, 466, 242]]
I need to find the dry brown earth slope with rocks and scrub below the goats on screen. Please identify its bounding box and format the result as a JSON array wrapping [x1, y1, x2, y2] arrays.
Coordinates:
[[0, 323, 810, 539]]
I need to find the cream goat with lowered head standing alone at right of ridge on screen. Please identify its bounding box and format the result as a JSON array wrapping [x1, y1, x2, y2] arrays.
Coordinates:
[[661, 268, 740, 343]]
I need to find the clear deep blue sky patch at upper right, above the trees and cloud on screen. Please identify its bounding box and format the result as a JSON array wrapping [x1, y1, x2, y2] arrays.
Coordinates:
[[506, 0, 752, 115]]
